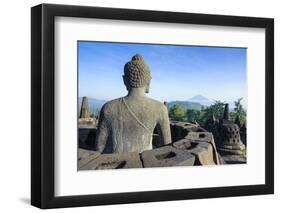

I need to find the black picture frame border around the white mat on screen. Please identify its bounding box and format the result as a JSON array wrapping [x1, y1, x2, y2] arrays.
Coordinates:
[[31, 4, 274, 209]]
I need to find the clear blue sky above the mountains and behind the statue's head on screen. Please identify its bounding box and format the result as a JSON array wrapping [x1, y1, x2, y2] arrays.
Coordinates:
[[78, 41, 247, 103]]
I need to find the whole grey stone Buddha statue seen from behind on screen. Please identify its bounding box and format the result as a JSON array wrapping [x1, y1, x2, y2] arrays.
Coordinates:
[[95, 54, 171, 153]]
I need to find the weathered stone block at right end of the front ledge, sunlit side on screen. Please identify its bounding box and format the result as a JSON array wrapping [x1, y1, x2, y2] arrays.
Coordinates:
[[173, 139, 216, 165]]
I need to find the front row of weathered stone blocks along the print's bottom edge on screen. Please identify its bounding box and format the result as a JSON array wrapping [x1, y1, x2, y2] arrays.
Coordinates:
[[78, 132, 219, 170]]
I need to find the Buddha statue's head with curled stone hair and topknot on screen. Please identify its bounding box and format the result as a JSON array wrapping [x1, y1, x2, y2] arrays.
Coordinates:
[[123, 54, 151, 93]]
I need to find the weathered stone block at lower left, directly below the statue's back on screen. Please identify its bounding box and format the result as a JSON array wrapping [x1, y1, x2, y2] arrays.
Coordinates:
[[81, 152, 143, 170]]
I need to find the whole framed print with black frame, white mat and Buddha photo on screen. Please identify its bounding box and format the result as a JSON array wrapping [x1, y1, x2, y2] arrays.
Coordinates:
[[31, 4, 274, 208]]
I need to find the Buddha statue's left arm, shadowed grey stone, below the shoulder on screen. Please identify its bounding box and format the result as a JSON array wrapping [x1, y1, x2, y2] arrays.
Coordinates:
[[95, 110, 109, 152]]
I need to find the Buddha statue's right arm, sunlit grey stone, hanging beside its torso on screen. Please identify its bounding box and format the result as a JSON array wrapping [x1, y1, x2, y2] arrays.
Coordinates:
[[159, 105, 172, 145]]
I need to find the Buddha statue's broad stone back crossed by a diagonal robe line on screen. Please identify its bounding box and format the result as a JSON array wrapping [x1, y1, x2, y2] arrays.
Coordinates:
[[94, 97, 168, 153]]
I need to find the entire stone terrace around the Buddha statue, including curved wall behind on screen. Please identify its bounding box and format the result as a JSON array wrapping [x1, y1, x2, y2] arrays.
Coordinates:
[[78, 121, 246, 170]]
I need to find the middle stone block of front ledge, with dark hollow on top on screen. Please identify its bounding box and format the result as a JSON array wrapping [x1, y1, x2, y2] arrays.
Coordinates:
[[141, 146, 195, 167]]
